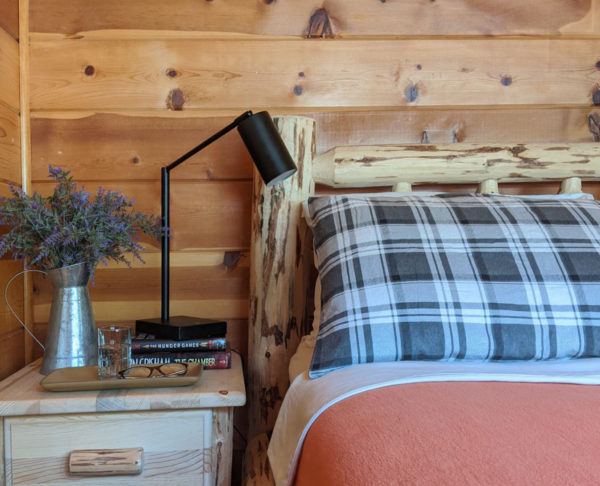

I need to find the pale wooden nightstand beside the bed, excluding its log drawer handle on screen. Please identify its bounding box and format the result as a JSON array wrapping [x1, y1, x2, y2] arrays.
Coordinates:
[[0, 354, 246, 486]]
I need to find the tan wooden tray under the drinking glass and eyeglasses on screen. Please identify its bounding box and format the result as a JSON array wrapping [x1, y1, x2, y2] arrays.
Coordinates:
[[40, 363, 202, 391]]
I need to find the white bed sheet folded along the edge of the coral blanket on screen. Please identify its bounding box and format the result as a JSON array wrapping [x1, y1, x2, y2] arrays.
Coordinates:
[[268, 358, 600, 486]]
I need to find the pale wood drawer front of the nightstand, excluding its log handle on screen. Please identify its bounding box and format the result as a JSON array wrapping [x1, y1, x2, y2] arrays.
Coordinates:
[[4, 410, 213, 486]]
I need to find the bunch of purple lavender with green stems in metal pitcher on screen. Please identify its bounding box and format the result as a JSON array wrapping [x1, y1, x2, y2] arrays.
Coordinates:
[[0, 166, 160, 277]]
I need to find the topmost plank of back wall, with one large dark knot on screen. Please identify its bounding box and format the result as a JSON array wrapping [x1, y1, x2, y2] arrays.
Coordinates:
[[31, 0, 599, 35]]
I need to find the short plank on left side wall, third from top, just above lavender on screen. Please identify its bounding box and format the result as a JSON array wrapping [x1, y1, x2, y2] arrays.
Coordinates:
[[0, 104, 21, 184]]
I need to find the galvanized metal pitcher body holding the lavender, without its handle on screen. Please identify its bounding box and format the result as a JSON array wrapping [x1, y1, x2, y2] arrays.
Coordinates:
[[40, 263, 98, 375]]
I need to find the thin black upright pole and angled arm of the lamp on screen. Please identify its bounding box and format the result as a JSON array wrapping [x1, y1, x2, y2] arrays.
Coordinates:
[[160, 111, 252, 322]]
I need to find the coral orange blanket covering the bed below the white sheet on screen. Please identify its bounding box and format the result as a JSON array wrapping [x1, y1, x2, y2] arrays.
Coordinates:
[[294, 382, 600, 486]]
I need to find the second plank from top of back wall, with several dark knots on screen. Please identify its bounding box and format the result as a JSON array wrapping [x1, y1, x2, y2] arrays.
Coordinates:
[[31, 39, 600, 110]]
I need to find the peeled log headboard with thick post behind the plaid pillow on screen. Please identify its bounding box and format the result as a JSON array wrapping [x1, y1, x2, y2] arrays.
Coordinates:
[[245, 116, 600, 484]]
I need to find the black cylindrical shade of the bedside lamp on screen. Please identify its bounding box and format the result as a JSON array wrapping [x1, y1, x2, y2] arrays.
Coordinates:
[[238, 111, 297, 186]]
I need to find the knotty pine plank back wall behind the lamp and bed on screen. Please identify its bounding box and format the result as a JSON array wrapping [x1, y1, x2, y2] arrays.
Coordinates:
[[29, 0, 600, 436]]
